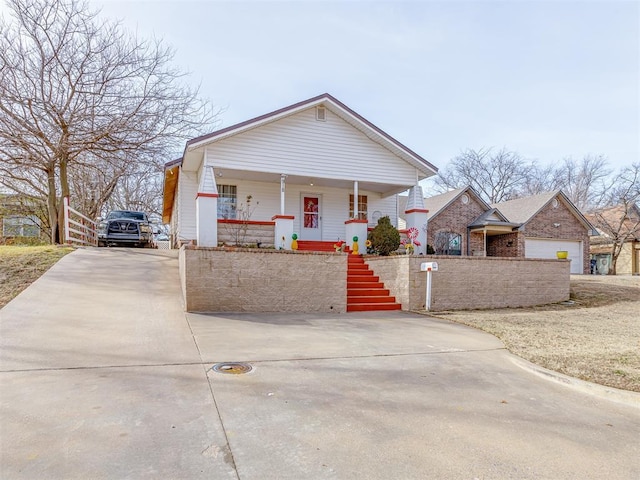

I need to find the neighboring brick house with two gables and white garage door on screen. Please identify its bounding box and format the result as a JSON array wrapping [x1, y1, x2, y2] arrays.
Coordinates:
[[399, 187, 593, 273]]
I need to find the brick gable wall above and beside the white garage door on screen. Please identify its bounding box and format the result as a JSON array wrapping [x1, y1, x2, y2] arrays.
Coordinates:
[[522, 201, 590, 274]]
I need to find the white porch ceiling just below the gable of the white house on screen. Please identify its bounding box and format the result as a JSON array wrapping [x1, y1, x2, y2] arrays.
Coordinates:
[[213, 167, 412, 195]]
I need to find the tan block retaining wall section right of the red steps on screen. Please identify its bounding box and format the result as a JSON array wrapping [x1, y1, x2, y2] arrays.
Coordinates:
[[366, 255, 570, 311]]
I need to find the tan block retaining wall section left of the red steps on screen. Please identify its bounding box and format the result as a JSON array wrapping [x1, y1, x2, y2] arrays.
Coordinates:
[[179, 246, 347, 313]]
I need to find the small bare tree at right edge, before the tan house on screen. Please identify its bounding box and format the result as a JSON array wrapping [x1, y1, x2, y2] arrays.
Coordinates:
[[587, 162, 640, 275]]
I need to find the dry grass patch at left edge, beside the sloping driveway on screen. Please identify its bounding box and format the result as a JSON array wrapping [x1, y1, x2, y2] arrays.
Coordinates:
[[0, 246, 73, 308]]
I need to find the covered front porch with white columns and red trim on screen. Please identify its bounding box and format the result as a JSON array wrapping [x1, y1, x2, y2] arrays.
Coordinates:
[[183, 161, 426, 253]]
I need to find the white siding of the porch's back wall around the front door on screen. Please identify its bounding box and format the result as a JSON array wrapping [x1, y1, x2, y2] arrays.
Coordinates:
[[222, 178, 397, 241]]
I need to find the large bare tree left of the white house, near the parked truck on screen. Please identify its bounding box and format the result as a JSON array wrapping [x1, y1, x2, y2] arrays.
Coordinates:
[[0, 0, 216, 242]]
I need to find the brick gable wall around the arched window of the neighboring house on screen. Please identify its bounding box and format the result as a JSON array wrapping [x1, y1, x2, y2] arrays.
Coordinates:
[[427, 195, 485, 255]]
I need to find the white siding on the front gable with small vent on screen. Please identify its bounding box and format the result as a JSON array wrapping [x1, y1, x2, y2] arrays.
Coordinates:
[[206, 108, 416, 185]]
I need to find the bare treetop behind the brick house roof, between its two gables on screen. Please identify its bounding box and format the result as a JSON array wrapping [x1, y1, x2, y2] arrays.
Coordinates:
[[436, 148, 535, 203]]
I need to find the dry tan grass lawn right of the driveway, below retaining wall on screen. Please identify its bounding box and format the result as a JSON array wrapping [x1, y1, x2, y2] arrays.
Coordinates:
[[424, 275, 640, 392]]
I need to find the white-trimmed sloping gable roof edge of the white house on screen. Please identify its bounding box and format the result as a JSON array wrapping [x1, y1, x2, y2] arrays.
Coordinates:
[[175, 93, 438, 176]]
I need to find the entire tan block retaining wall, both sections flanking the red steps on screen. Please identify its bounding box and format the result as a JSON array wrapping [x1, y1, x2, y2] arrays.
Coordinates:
[[179, 246, 570, 313]]
